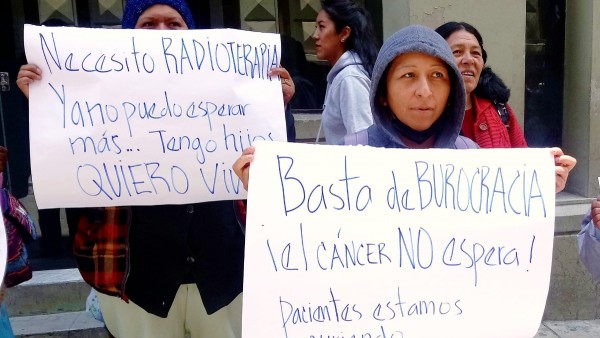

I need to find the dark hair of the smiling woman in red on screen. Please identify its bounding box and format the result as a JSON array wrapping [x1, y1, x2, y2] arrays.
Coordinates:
[[435, 21, 510, 103]]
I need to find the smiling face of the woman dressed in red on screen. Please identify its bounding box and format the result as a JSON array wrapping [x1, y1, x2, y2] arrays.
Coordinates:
[[446, 30, 483, 96]]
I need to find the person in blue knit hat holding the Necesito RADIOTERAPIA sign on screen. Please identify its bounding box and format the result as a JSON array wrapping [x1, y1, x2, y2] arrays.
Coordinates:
[[17, 0, 294, 338]]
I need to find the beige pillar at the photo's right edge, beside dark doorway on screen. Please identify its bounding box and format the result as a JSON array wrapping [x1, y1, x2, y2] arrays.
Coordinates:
[[563, 0, 600, 197]]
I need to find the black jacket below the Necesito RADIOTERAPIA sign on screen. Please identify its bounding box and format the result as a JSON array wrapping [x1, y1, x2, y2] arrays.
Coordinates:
[[125, 201, 244, 318]]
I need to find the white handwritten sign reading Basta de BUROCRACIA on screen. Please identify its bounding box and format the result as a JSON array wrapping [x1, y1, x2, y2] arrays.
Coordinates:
[[243, 142, 555, 338]]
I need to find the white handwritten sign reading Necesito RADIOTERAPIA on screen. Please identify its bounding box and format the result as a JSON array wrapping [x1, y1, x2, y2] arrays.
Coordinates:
[[25, 25, 286, 208]]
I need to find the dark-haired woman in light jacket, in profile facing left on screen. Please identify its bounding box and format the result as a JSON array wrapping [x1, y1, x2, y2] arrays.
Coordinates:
[[312, 0, 378, 144]]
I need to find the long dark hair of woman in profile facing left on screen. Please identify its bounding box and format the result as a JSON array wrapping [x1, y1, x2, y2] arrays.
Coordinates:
[[321, 0, 379, 76]]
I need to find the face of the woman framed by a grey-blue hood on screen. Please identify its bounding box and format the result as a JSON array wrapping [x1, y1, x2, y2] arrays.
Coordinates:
[[382, 52, 450, 131]]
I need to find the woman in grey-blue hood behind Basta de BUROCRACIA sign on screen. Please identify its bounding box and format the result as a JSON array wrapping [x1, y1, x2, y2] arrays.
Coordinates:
[[367, 25, 477, 148]]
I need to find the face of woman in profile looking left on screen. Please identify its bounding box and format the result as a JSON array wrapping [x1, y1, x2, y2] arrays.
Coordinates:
[[312, 10, 345, 65]]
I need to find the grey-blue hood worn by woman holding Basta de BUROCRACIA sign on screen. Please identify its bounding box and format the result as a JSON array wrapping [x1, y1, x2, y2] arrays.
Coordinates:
[[370, 25, 465, 148]]
